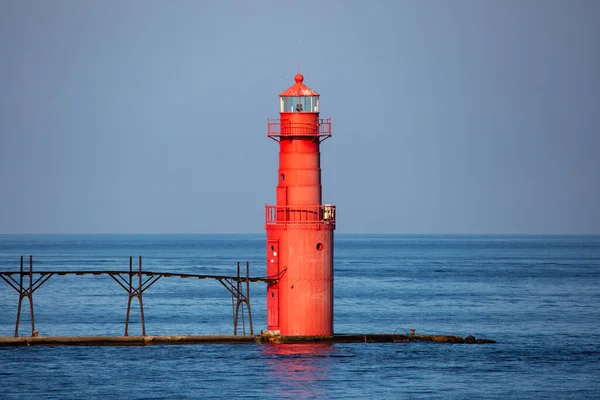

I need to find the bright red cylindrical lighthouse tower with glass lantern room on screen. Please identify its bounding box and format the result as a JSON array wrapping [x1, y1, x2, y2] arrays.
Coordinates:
[[265, 74, 335, 336]]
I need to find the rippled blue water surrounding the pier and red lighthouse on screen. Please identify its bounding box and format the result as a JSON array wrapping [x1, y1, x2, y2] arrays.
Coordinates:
[[0, 235, 600, 399]]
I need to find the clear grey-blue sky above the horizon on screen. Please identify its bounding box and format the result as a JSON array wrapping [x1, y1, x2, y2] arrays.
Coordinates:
[[0, 0, 600, 233]]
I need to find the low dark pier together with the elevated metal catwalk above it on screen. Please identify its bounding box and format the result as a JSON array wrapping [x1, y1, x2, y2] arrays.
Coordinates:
[[0, 256, 495, 347]]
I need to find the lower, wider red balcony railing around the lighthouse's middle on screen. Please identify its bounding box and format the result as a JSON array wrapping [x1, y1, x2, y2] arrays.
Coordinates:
[[265, 204, 335, 228]]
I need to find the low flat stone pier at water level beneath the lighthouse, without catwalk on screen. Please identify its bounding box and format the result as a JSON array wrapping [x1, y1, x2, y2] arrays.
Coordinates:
[[0, 333, 496, 347]]
